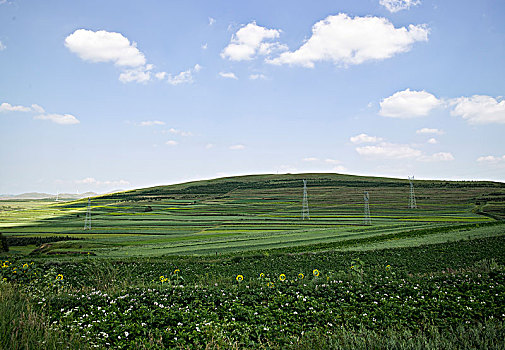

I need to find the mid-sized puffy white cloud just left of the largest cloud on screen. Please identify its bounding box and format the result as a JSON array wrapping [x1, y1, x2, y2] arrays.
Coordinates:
[[221, 21, 287, 61]]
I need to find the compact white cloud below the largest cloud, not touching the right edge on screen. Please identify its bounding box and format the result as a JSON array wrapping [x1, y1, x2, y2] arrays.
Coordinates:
[[379, 89, 443, 118]]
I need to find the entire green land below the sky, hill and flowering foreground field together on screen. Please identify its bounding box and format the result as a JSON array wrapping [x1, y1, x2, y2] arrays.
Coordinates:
[[0, 174, 505, 349]]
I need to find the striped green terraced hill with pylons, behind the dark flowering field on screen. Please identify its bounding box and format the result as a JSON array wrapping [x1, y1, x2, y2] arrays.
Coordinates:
[[0, 173, 505, 257]]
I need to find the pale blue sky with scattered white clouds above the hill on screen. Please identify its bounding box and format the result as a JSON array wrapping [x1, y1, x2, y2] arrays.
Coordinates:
[[0, 0, 505, 194]]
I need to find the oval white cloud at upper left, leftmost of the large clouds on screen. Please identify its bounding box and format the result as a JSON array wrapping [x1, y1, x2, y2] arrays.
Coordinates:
[[65, 29, 146, 67]]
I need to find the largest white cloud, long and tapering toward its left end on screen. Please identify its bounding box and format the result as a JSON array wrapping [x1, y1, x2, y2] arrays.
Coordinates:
[[267, 13, 429, 68]]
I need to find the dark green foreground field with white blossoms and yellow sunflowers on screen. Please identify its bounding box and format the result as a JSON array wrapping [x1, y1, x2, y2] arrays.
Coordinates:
[[0, 237, 505, 349]]
